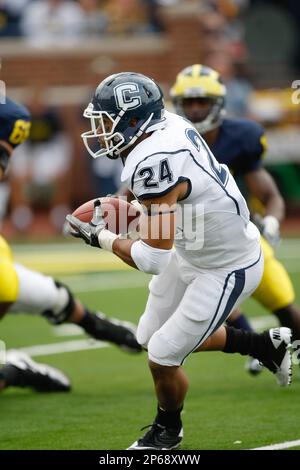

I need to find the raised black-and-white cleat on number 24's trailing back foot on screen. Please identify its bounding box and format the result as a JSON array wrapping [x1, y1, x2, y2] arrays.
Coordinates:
[[258, 327, 292, 387]]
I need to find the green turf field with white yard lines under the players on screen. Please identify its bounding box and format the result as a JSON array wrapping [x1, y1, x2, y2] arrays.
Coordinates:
[[0, 240, 300, 450]]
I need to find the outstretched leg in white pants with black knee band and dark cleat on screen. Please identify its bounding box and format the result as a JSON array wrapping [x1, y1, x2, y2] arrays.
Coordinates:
[[9, 263, 142, 352]]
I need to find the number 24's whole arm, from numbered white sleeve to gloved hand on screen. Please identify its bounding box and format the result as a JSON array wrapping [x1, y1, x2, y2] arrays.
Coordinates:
[[67, 152, 190, 274]]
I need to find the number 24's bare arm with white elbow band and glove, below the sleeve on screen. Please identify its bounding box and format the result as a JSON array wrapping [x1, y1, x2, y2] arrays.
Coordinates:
[[67, 182, 188, 274]]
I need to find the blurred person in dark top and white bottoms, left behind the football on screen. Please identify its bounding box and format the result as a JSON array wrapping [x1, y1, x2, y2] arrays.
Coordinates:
[[7, 84, 74, 233]]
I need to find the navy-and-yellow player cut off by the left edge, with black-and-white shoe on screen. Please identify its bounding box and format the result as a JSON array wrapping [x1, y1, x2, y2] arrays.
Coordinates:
[[0, 100, 71, 392]]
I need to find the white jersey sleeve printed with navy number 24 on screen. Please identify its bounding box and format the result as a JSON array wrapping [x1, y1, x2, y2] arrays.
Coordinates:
[[131, 154, 187, 200]]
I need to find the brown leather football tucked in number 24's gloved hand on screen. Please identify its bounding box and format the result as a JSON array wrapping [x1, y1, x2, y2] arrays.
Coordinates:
[[72, 197, 141, 234]]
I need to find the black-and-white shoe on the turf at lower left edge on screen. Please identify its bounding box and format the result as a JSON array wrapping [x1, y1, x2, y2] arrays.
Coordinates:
[[5, 350, 71, 392]]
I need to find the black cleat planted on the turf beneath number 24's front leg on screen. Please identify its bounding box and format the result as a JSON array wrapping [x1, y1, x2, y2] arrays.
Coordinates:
[[127, 422, 183, 450]]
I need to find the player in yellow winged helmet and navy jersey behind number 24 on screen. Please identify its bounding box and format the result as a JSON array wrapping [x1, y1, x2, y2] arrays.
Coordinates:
[[170, 64, 300, 374]]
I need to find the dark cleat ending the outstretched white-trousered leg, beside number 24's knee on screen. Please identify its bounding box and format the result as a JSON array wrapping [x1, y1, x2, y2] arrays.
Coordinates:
[[95, 312, 143, 353]]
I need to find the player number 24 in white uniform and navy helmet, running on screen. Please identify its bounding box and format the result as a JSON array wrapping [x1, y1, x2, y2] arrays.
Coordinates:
[[67, 72, 291, 450]]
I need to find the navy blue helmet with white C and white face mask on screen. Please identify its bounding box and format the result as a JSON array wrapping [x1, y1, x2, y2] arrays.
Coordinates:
[[82, 72, 165, 158]]
